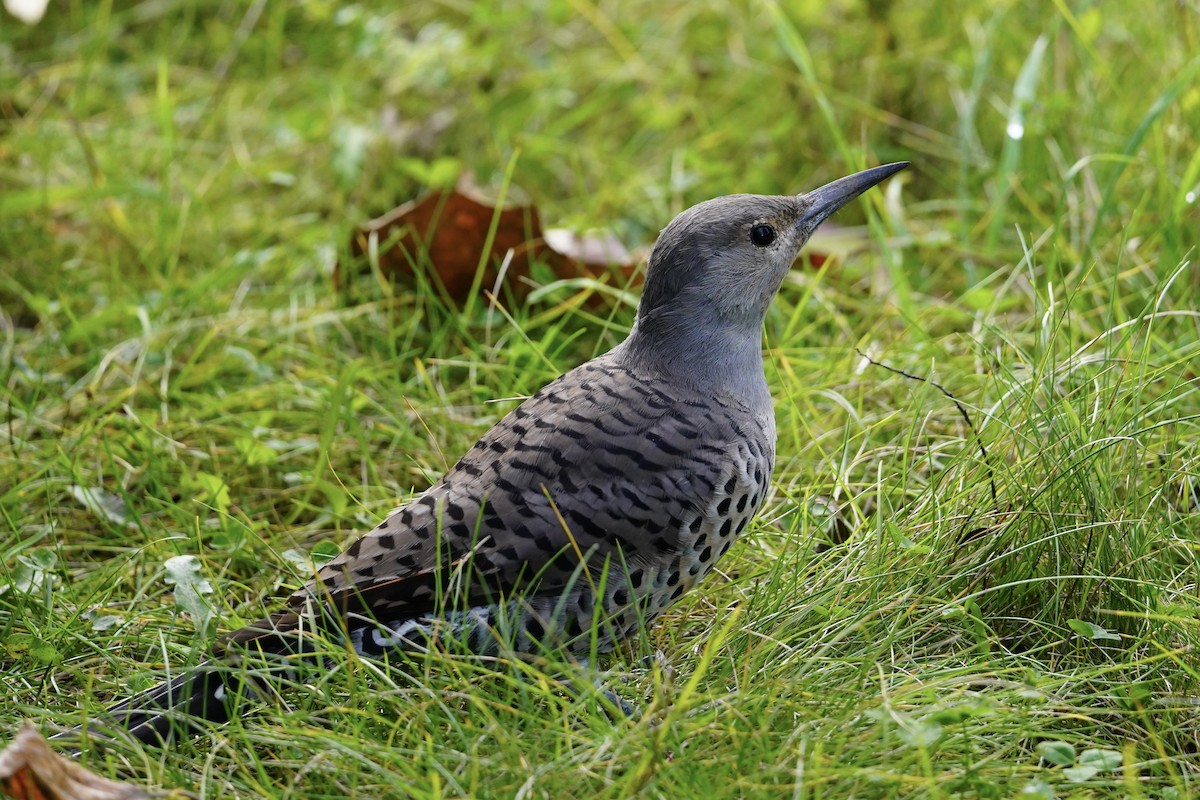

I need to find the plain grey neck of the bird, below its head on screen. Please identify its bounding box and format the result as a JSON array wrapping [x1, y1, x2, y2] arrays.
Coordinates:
[[612, 304, 770, 413]]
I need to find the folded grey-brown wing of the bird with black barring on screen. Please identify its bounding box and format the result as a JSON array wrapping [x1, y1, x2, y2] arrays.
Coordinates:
[[280, 357, 752, 620]]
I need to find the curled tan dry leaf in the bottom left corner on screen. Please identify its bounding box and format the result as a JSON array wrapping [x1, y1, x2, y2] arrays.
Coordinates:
[[0, 722, 150, 800]]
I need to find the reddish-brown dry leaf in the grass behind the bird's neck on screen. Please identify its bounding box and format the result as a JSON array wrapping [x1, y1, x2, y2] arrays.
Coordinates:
[[334, 181, 636, 301]]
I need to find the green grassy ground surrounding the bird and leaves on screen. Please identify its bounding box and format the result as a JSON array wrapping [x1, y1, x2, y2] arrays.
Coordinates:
[[0, 0, 1200, 799]]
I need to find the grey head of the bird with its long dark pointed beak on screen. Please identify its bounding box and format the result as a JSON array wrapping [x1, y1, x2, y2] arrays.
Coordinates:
[[637, 162, 908, 336]]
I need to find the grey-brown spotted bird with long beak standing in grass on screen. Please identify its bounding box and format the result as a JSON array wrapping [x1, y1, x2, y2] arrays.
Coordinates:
[[68, 162, 908, 745]]
